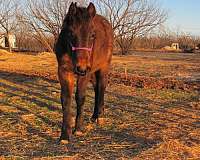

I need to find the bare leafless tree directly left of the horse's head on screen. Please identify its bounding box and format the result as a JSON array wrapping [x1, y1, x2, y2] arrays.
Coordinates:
[[22, 0, 84, 52]]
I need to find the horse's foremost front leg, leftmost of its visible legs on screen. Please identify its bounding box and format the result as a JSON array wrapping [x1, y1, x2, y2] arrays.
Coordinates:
[[58, 69, 74, 143]]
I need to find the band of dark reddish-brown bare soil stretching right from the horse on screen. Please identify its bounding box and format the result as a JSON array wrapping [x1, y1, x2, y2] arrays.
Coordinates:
[[109, 73, 200, 91]]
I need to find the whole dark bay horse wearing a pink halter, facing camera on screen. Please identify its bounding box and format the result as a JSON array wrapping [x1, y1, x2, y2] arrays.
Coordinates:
[[55, 2, 113, 142]]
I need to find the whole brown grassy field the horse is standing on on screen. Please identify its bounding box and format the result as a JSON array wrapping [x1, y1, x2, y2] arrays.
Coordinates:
[[0, 51, 200, 160]]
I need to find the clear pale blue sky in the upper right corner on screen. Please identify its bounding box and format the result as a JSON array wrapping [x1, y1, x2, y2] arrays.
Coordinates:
[[159, 0, 200, 36]]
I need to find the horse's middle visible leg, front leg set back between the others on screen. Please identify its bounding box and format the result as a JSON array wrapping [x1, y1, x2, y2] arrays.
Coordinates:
[[75, 76, 88, 135]]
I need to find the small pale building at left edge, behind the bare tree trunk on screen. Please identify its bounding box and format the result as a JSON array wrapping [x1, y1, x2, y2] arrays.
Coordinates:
[[0, 34, 17, 48]]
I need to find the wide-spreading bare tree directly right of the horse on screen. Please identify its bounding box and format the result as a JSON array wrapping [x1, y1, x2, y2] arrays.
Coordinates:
[[93, 0, 167, 54]]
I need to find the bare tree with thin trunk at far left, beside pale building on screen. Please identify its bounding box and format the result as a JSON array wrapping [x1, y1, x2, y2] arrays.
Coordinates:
[[0, 0, 19, 52]]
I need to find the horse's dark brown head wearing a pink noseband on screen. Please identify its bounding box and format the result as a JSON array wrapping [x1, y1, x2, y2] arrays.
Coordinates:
[[63, 2, 96, 76]]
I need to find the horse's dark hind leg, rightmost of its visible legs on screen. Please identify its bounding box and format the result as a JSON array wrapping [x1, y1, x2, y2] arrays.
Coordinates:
[[91, 70, 107, 122]]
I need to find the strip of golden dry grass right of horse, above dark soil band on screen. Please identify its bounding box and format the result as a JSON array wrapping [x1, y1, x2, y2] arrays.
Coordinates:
[[113, 52, 200, 79]]
